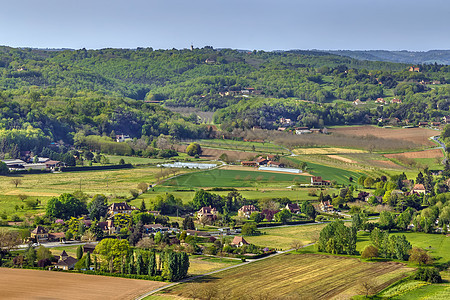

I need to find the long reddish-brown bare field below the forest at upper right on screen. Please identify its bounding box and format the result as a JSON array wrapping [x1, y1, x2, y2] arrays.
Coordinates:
[[328, 125, 439, 146]]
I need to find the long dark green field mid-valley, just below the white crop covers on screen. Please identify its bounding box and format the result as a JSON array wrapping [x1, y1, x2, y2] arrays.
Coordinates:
[[159, 169, 310, 188]]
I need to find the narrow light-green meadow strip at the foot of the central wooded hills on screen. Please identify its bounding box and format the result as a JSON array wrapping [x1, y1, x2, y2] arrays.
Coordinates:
[[198, 139, 288, 154]]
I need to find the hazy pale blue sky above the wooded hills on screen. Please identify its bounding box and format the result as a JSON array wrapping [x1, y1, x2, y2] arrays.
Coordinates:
[[0, 0, 450, 50]]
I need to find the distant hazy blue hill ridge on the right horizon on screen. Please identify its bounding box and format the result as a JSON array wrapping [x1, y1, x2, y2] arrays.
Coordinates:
[[324, 50, 450, 65]]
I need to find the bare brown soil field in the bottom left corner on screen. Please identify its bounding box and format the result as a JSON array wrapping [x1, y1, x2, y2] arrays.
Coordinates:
[[0, 268, 167, 300]]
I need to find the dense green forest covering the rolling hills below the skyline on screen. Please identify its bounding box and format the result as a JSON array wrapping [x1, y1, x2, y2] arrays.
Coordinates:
[[0, 47, 450, 153]]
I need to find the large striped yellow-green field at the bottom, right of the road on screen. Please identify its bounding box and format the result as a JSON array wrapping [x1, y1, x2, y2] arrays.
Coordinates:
[[162, 254, 411, 299]]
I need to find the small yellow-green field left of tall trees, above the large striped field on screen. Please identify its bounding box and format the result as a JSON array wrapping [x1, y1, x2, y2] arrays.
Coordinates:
[[245, 224, 326, 250]]
